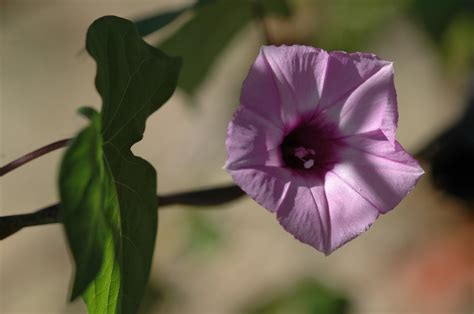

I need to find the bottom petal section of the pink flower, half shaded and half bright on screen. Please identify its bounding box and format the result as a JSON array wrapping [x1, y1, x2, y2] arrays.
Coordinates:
[[277, 172, 380, 255]]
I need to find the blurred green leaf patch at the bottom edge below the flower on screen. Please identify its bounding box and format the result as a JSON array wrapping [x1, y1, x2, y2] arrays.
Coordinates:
[[244, 279, 349, 314]]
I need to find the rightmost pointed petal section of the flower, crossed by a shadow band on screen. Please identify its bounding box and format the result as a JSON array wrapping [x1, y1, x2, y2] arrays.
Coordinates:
[[331, 130, 423, 213]]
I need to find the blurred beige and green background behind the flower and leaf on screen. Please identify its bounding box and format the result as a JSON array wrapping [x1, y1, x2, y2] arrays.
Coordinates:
[[0, 0, 474, 314]]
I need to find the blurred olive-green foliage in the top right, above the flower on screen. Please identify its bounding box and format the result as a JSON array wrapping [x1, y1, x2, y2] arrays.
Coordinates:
[[305, 0, 474, 71]]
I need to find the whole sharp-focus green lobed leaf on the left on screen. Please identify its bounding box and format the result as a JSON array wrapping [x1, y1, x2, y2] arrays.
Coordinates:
[[59, 16, 180, 314]]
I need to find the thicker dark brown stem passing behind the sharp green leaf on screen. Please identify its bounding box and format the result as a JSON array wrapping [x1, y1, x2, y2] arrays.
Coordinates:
[[0, 184, 245, 240]]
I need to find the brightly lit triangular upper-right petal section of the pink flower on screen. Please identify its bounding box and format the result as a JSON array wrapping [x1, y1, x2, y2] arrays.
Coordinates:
[[320, 63, 398, 143]]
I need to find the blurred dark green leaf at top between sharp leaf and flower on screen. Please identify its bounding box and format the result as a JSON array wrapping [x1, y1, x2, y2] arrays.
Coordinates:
[[159, 0, 289, 94]]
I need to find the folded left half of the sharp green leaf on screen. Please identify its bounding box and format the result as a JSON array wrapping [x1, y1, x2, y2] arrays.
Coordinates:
[[59, 108, 109, 298]]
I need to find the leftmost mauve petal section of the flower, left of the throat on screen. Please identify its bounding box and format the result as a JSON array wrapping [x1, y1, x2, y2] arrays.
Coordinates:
[[224, 107, 284, 170]]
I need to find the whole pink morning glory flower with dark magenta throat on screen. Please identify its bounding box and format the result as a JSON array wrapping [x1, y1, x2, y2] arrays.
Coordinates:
[[225, 46, 423, 254]]
